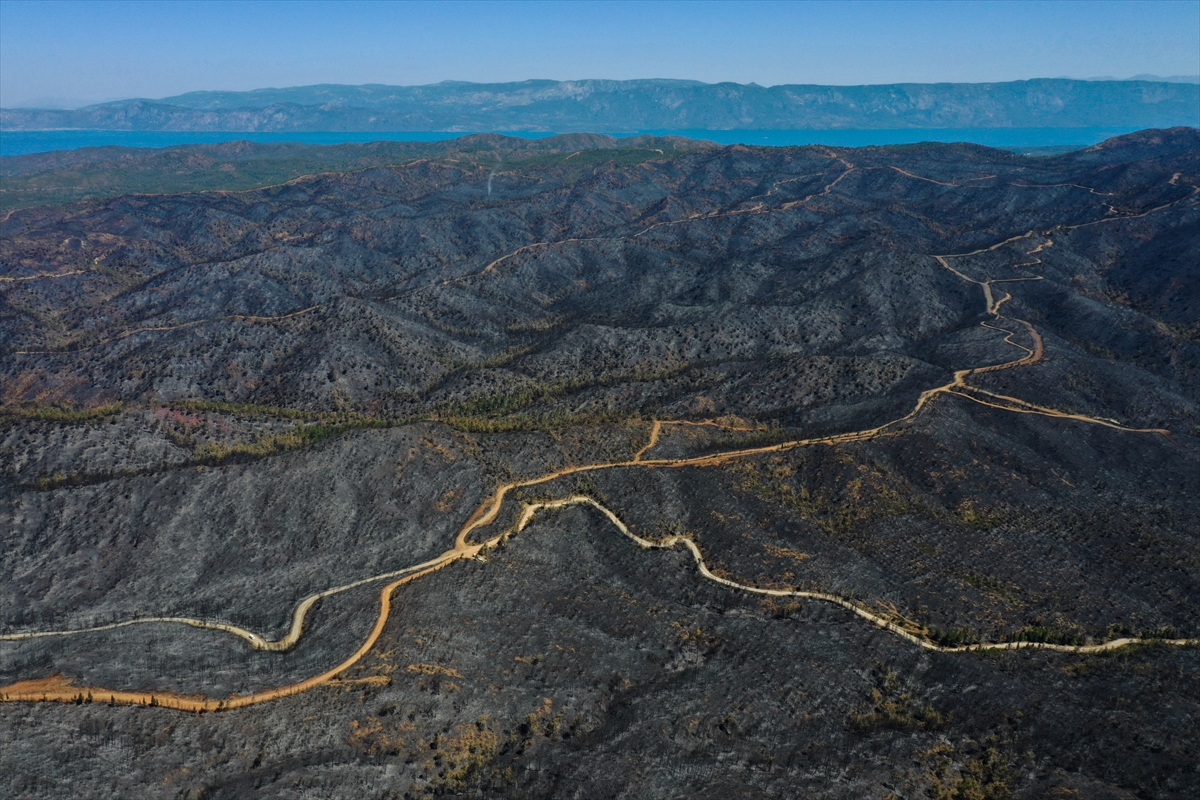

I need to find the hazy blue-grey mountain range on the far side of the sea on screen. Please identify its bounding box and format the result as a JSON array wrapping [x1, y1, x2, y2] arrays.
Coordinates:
[[0, 78, 1200, 132]]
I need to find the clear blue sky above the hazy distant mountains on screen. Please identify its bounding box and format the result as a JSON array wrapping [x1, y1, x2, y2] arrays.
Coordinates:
[[0, 0, 1200, 107]]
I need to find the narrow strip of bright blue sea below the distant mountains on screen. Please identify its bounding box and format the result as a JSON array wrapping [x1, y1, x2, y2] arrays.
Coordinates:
[[0, 127, 1138, 156]]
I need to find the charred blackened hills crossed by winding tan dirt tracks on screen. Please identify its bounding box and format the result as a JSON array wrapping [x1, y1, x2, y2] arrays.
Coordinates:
[[0, 128, 1200, 799]]
